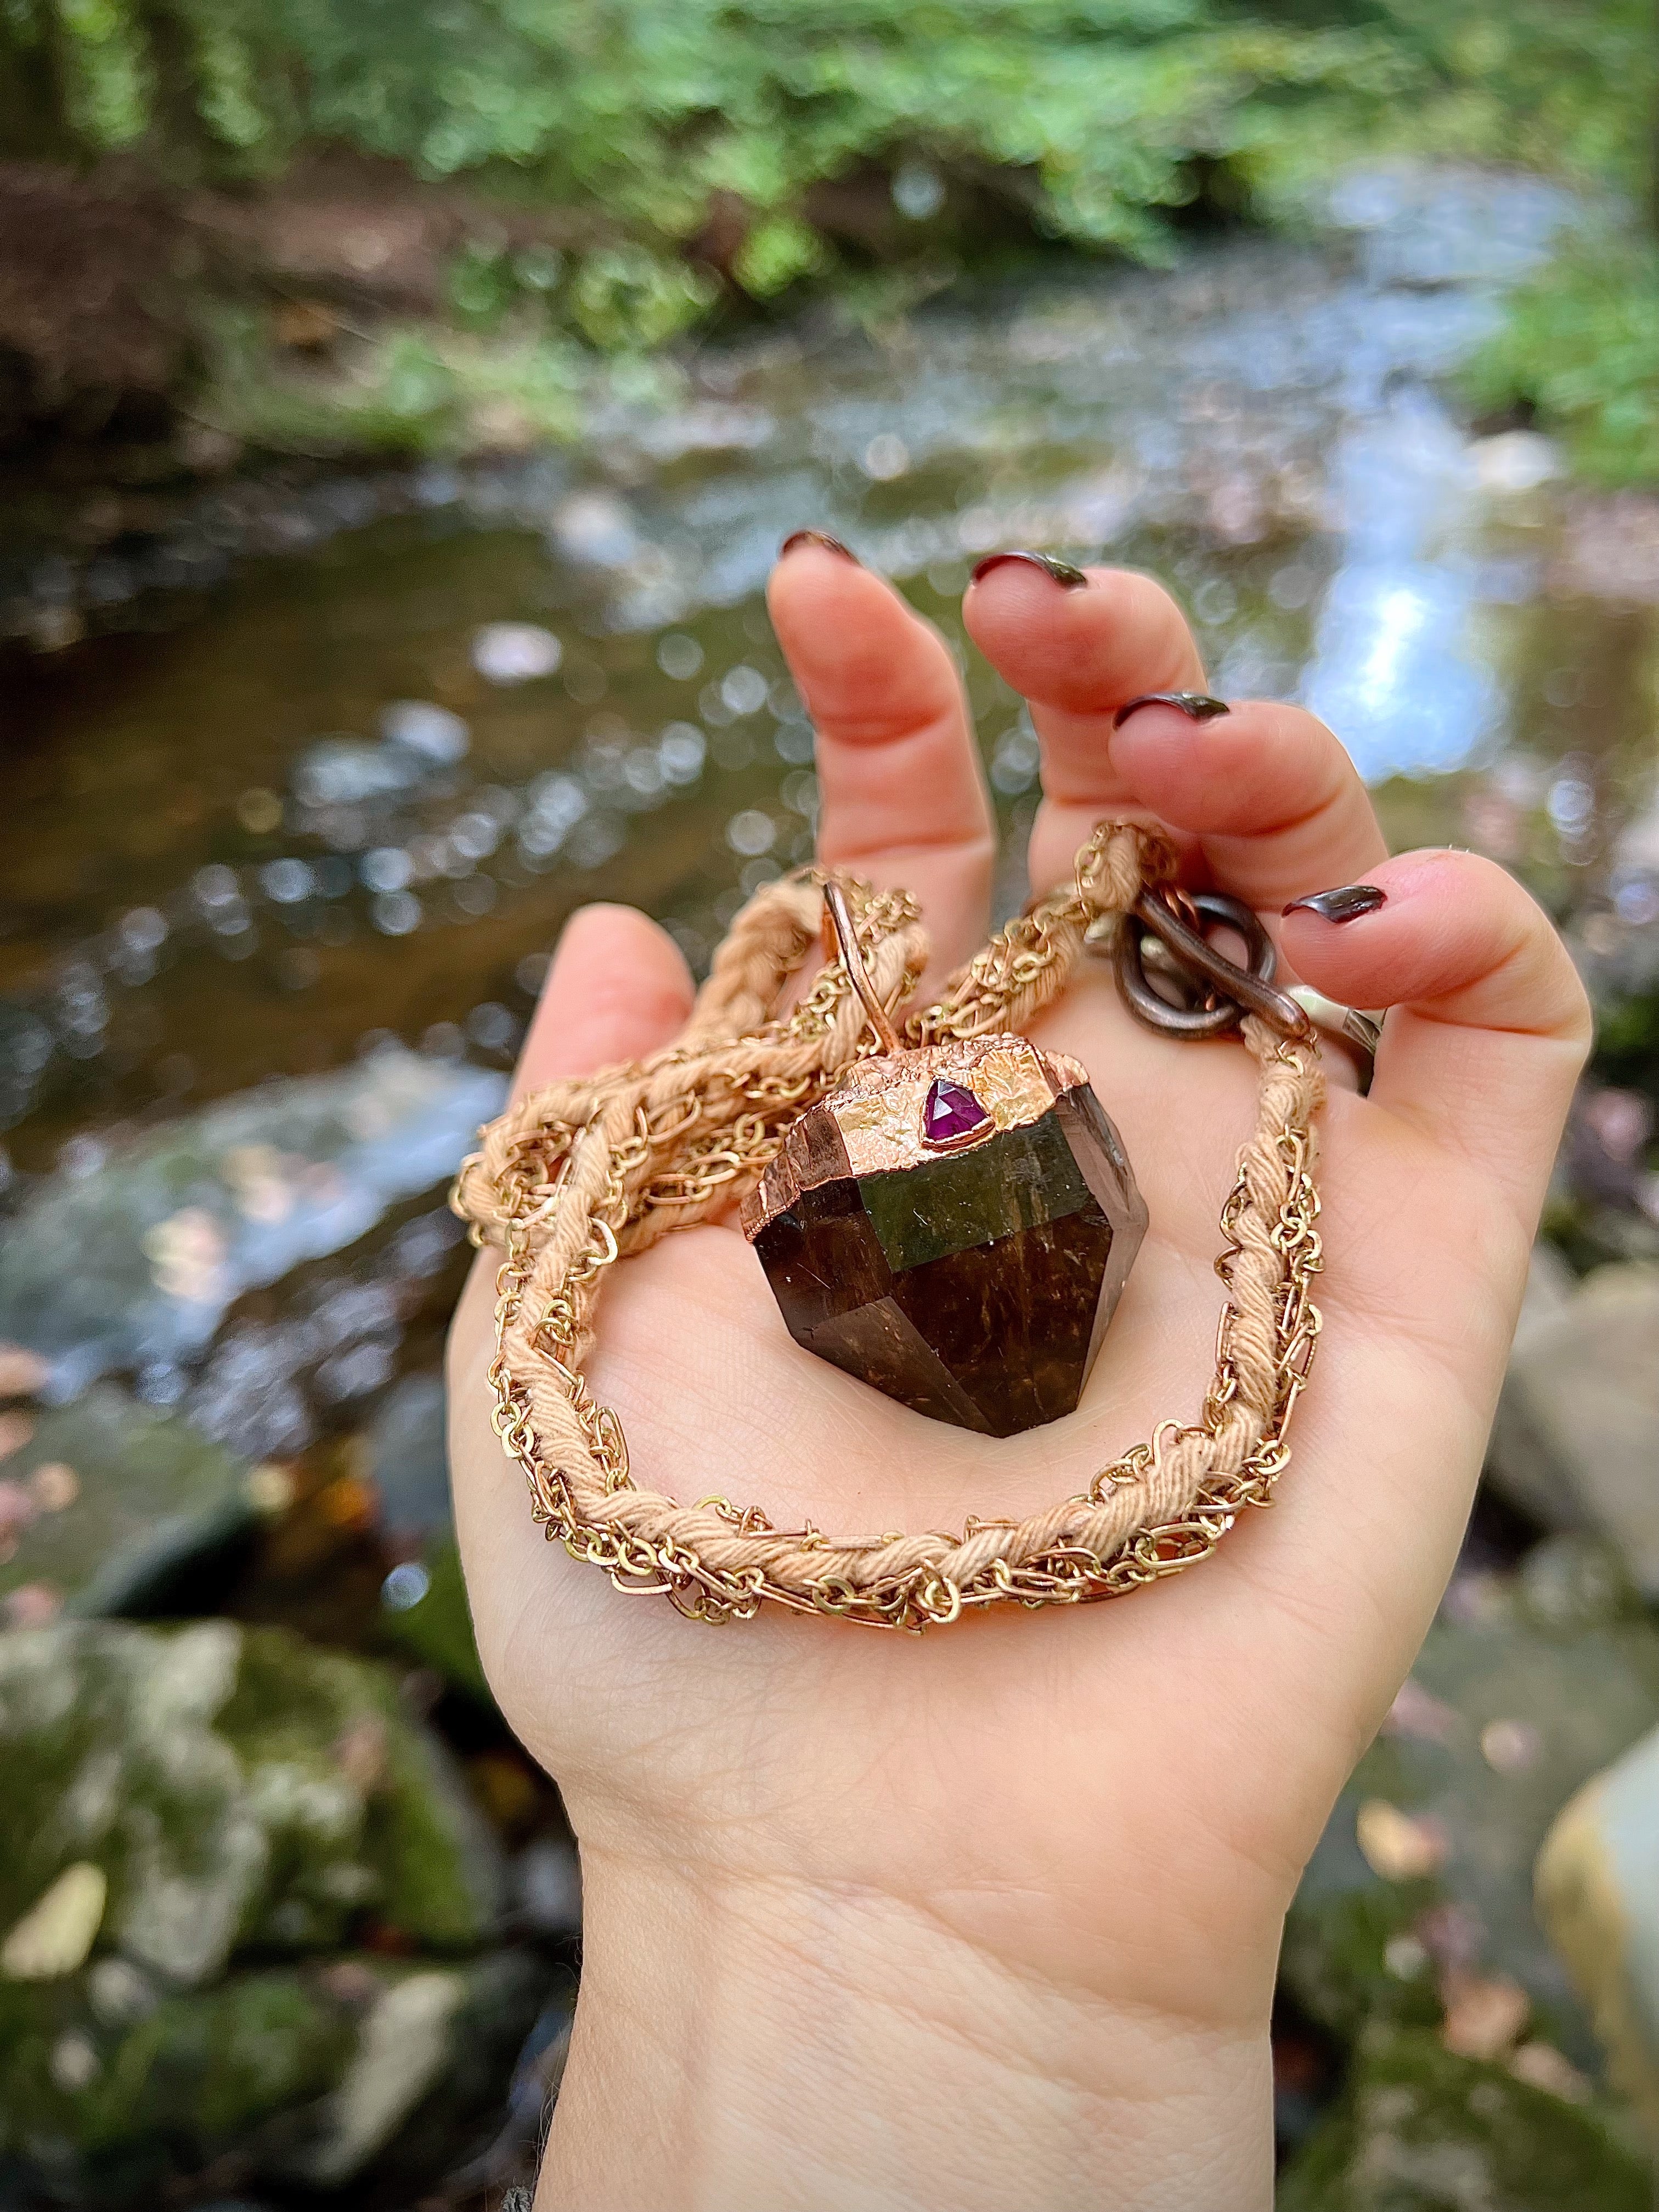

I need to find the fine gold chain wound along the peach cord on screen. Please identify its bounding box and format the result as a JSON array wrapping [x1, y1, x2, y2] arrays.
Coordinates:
[[456, 823, 1321, 1628]]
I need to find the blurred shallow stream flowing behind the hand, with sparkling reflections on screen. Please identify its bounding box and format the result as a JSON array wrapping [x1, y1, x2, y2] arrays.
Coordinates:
[[0, 160, 1659, 1453]]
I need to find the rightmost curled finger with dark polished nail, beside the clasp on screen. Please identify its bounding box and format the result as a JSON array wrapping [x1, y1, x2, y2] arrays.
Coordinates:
[[1283, 851, 1590, 1223]]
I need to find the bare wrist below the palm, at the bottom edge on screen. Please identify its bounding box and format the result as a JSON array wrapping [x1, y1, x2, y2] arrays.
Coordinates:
[[538, 1856, 1272, 2212]]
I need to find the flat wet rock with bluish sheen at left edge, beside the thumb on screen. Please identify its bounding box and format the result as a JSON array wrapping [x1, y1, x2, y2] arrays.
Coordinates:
[[0, 1046, 504, 1398]]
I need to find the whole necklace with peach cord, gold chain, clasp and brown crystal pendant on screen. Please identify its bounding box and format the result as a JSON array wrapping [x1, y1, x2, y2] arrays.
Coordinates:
[[452, 823, 1323, 1628]]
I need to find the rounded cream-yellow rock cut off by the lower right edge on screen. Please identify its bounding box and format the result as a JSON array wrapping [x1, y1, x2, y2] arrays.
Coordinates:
[[1537, 1730, 1659, 2148]]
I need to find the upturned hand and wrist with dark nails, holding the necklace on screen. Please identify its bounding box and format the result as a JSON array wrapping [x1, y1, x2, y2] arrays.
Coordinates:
[[452, 544, 1588, 2212]]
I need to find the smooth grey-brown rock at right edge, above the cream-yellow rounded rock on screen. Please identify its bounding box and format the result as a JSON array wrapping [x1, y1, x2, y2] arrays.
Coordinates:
[[1489, 1265, 1659, 1597]]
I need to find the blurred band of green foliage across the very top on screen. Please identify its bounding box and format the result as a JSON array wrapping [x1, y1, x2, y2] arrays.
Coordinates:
[[0, 0, 1652, 273]]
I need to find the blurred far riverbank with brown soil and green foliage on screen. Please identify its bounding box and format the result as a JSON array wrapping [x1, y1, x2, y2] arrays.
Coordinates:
[[0, 0, 1659, 506]]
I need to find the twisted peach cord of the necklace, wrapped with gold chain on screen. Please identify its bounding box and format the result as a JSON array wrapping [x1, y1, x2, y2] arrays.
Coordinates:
[[452, 823, 1323, 1628]]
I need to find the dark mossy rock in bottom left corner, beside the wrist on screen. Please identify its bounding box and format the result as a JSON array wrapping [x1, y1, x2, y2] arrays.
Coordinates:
[[0, 1951, 555, 2212]]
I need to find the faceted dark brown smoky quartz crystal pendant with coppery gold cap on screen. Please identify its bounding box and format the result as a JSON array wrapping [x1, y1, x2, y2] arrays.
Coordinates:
[[746, 1040, 1146, 1436]]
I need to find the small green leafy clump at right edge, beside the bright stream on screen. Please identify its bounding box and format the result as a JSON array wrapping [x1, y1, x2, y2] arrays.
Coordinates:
[[1466, 234, 1659, 484]]
